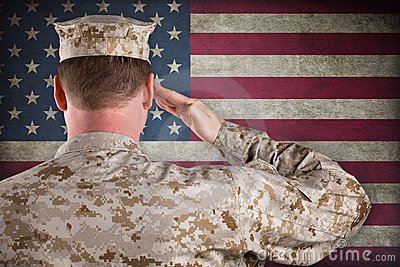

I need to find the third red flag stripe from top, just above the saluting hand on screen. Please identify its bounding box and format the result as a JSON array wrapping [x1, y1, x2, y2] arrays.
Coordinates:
[[190, 77, 400, 99]]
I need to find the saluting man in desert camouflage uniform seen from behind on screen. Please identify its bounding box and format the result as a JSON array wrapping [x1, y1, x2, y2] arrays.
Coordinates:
[[0, 15, 371, 266]]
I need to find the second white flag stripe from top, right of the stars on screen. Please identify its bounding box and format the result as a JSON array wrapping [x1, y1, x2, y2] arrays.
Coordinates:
[[190, 55, 400, 77]]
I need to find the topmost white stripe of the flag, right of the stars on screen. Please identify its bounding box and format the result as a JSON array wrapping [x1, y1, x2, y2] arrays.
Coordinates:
[[190, 14, 400, 33]]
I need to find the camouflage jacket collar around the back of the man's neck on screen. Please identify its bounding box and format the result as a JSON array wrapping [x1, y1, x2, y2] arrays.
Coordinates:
[[55, 132, 146, 157]]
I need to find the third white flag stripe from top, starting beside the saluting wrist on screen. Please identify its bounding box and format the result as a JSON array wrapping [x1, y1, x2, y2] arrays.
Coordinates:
[[202, 99, 400, 119]]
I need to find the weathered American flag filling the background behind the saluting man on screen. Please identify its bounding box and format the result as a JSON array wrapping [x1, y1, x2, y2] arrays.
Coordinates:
[[0, 0, 400, 266]]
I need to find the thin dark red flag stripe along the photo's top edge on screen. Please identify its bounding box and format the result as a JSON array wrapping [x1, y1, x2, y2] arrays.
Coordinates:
[[190, 0, 400, 14]]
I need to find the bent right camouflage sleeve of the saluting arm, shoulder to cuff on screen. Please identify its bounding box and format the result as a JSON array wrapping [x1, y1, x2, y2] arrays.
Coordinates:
[[213, 121, 371, 265]]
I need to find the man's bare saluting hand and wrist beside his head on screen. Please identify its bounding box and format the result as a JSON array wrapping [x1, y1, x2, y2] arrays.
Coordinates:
[[154, 83, 225, 144]]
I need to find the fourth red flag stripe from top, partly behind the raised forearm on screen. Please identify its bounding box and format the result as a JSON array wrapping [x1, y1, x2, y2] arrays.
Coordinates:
[[190, 119, 400, 141]]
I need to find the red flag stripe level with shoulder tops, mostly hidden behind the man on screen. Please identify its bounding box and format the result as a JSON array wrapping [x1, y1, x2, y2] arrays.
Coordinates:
[[0, 161, 400, 183]]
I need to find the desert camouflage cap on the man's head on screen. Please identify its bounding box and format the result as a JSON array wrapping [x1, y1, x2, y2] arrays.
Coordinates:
[[54, 15, 156, 63]]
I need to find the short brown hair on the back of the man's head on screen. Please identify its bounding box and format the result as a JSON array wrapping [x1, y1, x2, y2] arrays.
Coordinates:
[[58, 56, 151, 111]]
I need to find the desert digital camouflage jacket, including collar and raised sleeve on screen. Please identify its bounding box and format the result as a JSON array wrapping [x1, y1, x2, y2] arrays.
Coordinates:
[[0, 122, 371, 266]]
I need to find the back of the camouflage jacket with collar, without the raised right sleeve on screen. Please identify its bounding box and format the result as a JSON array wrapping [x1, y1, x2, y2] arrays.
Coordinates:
[[0, 133, 253, 266]]
